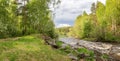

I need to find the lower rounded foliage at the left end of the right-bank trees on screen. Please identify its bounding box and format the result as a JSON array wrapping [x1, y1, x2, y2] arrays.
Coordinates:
[[69, 12, 93, 38]]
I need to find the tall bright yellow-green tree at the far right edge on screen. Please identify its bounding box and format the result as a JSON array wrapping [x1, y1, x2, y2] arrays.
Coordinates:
[[105, 0, 120, 39]]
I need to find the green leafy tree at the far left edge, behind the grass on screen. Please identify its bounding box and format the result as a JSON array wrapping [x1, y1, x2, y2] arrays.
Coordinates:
[[0, 0, 19, 37]]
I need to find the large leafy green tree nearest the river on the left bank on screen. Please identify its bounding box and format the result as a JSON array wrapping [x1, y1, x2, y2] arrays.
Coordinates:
[[21, 0, 58, 37]]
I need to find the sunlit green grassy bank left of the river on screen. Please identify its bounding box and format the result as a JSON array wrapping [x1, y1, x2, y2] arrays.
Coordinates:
[[0, 36, 70, 61]]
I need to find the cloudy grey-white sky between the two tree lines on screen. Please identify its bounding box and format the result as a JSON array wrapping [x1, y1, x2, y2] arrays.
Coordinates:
[[54, 0, 105, 27]]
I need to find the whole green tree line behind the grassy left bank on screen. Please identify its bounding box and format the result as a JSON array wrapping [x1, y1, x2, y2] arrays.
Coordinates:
[[0, 0, 58, 38]]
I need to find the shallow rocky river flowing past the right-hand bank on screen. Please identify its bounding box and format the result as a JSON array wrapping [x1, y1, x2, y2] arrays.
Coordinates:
[[60, 38, 120, 61]]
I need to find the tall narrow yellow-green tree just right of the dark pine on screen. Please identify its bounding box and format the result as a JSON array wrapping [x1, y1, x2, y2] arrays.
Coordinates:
[[96, 1, 107, 40]]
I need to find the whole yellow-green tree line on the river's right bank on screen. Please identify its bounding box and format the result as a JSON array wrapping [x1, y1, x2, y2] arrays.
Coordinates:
[[68, 0, 120, 42]]
